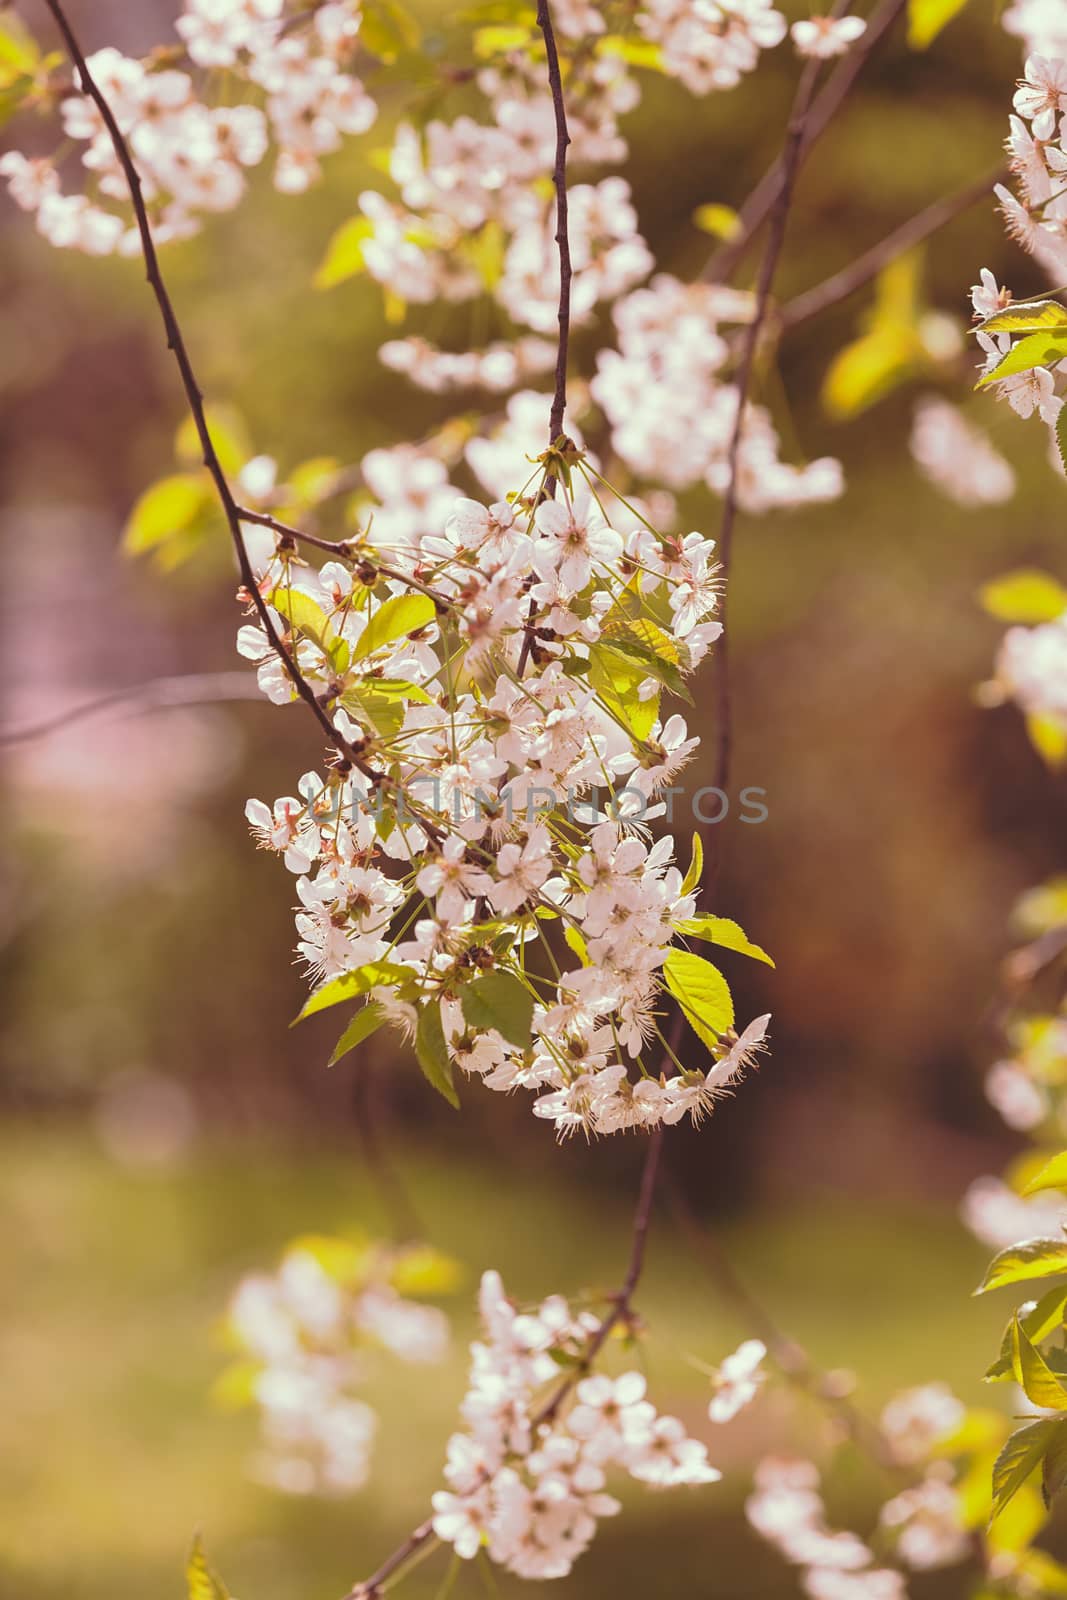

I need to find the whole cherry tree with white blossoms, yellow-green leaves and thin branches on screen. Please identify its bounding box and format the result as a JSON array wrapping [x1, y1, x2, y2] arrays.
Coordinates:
[[10, 0, 1067, 1600]]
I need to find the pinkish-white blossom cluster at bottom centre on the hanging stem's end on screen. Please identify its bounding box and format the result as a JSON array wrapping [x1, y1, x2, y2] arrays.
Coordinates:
[[434, 1272, 720, 1579]]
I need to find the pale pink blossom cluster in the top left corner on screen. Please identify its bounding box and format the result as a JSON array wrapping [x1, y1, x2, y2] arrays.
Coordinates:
[[0, 0, 376, 254]]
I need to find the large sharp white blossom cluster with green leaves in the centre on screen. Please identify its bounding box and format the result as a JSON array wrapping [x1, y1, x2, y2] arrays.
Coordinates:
[[238, 446, 768, 1133]]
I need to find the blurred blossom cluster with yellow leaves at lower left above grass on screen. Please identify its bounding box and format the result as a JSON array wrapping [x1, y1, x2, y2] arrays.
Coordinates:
[[219, 1238, 453, 1494]]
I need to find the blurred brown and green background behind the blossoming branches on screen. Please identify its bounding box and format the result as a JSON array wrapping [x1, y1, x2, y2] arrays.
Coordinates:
[[0, 0, 1064, 1600]]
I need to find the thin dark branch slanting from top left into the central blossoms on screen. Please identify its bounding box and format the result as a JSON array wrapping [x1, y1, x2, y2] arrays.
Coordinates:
[[35, 0, 412, 806]]
